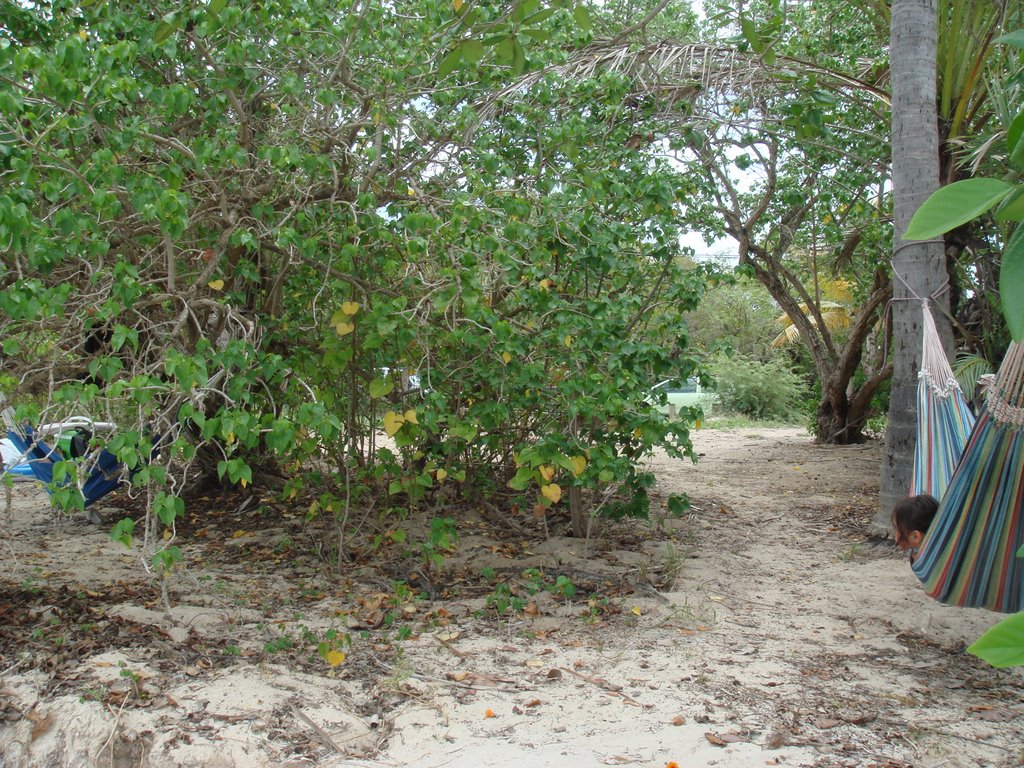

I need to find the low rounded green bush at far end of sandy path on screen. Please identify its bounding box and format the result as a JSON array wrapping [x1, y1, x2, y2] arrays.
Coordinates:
[[711, 355, 805, 419]]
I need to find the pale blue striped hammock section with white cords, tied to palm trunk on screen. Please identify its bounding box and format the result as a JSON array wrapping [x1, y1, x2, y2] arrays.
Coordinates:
[[910, 301, 974, 499]]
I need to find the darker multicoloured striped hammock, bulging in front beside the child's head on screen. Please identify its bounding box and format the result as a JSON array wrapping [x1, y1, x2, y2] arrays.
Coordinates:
[[913, 342, 1024, 612]]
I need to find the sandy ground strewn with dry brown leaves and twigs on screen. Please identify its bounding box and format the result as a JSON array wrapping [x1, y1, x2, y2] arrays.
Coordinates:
[[0, 429, 1024, 768]]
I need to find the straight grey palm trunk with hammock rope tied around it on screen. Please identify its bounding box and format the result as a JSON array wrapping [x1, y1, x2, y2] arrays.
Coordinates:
[[871, 0, 951, 535]]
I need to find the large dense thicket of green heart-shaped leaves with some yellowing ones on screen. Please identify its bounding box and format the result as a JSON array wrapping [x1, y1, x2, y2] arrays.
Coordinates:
[[0, 0, 707, 570]]
